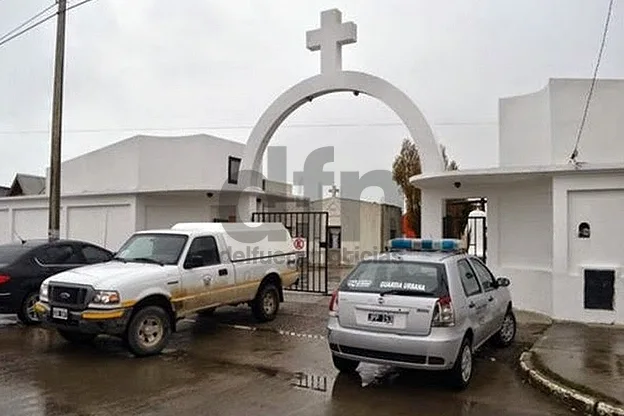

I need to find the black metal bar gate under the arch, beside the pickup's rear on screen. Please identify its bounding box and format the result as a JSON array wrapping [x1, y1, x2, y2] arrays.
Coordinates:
[[251, 211, 329, 295]]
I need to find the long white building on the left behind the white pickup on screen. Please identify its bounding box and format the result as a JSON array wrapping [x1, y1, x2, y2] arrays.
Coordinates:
[[0, 134, 300, 250]]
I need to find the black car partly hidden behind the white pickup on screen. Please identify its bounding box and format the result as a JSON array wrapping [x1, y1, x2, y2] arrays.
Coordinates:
[[0, 240, 113, 325]]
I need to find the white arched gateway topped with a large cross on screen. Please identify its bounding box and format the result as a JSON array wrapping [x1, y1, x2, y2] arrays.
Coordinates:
[[239, 9, 444, 236]]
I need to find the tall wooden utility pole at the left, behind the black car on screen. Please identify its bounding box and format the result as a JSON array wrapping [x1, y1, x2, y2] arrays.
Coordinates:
[[48, 0, 67, 241]]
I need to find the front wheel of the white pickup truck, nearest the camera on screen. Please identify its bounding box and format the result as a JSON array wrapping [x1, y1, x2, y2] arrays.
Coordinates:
[[125, 306, 171, 357]]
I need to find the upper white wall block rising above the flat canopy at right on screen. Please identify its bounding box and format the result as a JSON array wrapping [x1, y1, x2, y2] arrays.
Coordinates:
[[499, 79, 624, 167]]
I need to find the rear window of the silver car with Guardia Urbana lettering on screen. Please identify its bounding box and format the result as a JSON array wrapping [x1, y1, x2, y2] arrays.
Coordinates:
[[340, 261, 448, 297]]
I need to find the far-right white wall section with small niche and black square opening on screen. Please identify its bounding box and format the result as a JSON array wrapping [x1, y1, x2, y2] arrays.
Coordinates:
[[553, 175, 624, 324]]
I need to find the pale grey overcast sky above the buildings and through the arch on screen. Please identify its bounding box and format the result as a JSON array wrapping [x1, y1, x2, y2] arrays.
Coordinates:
[[0, 0, 624, 197]]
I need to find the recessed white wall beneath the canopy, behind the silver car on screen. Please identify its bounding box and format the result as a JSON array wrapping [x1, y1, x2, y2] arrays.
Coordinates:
[[416, 179, 553, 314]]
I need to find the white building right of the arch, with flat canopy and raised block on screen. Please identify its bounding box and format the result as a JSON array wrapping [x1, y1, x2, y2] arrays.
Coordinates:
[[412, 79, 624, 324]]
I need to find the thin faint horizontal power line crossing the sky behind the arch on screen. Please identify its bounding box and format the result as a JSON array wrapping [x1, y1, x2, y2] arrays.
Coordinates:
[[0, 122, 498, 135]]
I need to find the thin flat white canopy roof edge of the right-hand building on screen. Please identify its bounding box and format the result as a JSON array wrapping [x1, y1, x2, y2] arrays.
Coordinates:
[[410, 163, 624, 189]]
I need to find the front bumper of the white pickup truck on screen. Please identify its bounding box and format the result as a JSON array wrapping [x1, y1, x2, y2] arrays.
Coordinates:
[[35, 302, 130, 335]]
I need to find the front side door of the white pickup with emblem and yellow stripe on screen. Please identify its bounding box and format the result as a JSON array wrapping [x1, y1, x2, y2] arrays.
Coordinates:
[[181, 236, 235, 312]]
